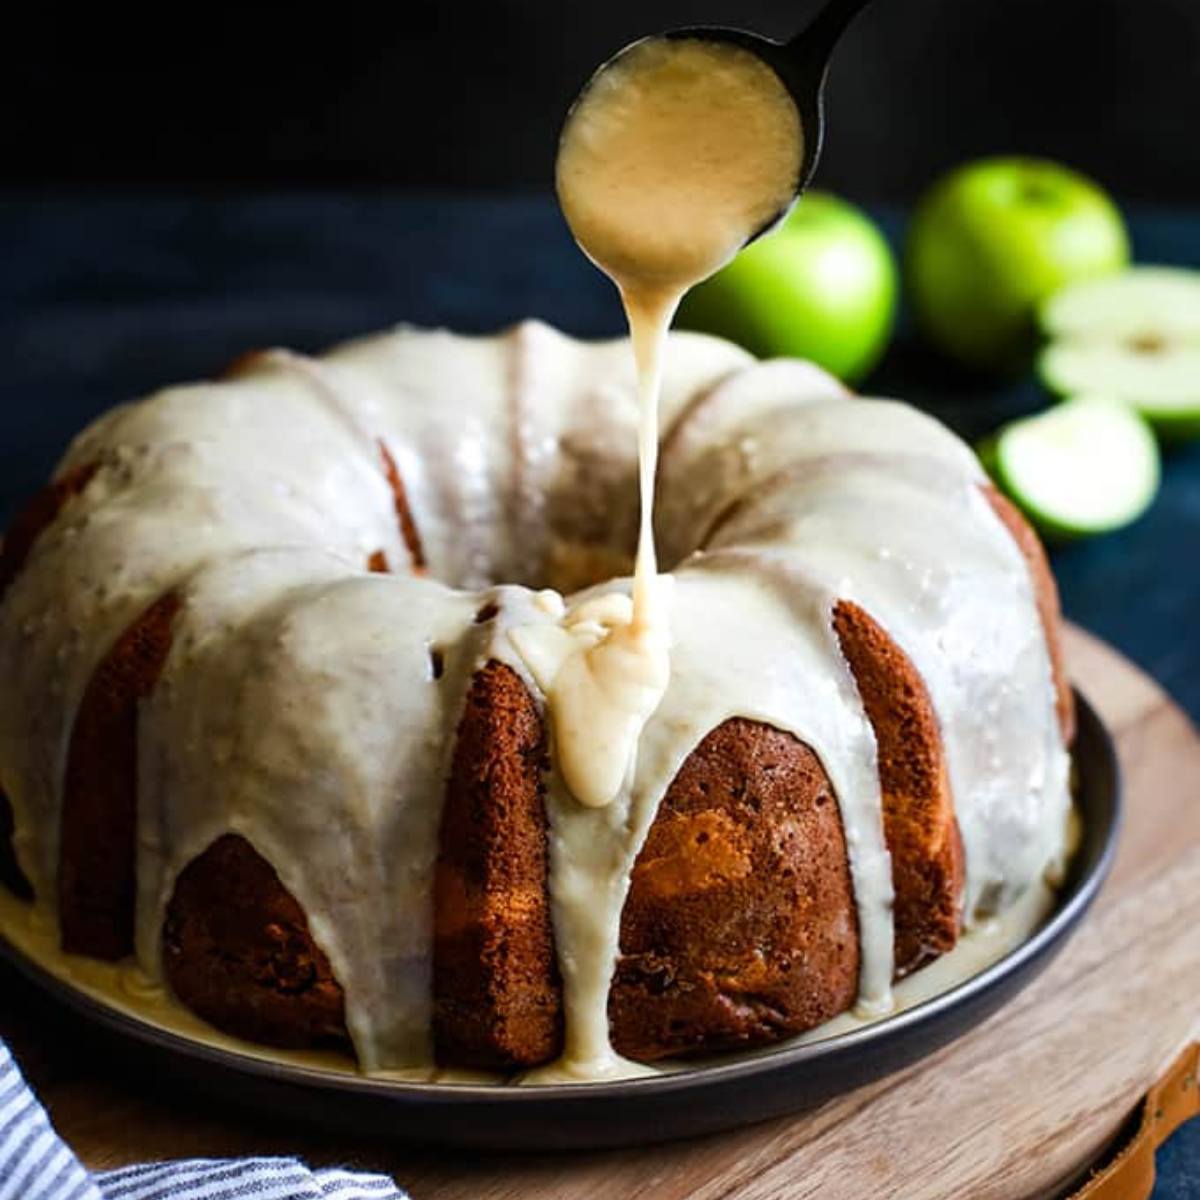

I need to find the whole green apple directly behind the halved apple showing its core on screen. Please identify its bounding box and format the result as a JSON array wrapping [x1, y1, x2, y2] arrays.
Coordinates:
[[905, 157, 1129, 371]]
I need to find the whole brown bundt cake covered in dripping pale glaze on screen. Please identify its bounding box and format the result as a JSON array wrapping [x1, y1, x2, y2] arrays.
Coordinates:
[[0, 323, 1072, 1070]]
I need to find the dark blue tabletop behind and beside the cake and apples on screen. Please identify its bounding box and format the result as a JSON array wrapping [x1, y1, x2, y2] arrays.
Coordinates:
[[0, 196, 1200, 1200]]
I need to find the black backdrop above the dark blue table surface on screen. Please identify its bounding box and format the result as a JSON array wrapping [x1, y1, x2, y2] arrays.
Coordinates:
[[7, 0, 1200, 203]]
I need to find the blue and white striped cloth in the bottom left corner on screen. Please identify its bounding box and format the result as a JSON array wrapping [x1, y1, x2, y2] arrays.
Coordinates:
[[0, 1042, 404, 1200]]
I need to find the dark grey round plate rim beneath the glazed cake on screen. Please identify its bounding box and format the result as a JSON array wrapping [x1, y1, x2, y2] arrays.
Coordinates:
[[0, 692, 1121, 1150]]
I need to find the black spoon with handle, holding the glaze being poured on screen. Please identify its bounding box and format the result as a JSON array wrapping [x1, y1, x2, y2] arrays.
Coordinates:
[[575, 0, 870, 244]]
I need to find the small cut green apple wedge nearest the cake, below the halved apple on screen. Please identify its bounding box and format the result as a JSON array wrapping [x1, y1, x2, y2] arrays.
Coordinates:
[[979, 396, 1159, 539]]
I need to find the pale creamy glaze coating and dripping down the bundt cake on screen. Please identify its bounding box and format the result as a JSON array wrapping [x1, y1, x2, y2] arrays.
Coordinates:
[[0, 325, 1068, 1074]]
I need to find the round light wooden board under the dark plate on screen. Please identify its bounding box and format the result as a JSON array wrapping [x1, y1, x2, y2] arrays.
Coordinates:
[[0, 630, 1200, 1200]]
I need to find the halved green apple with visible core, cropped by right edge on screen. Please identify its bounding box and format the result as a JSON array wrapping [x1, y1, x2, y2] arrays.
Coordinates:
[[1038, 266, 1200, 439]]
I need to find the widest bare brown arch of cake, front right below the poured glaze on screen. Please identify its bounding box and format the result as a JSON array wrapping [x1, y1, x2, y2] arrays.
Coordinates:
[[608, 718, 859, 1062]]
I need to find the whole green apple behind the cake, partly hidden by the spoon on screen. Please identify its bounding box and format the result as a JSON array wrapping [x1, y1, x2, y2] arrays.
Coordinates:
[[679, 192, 898, 382]]
